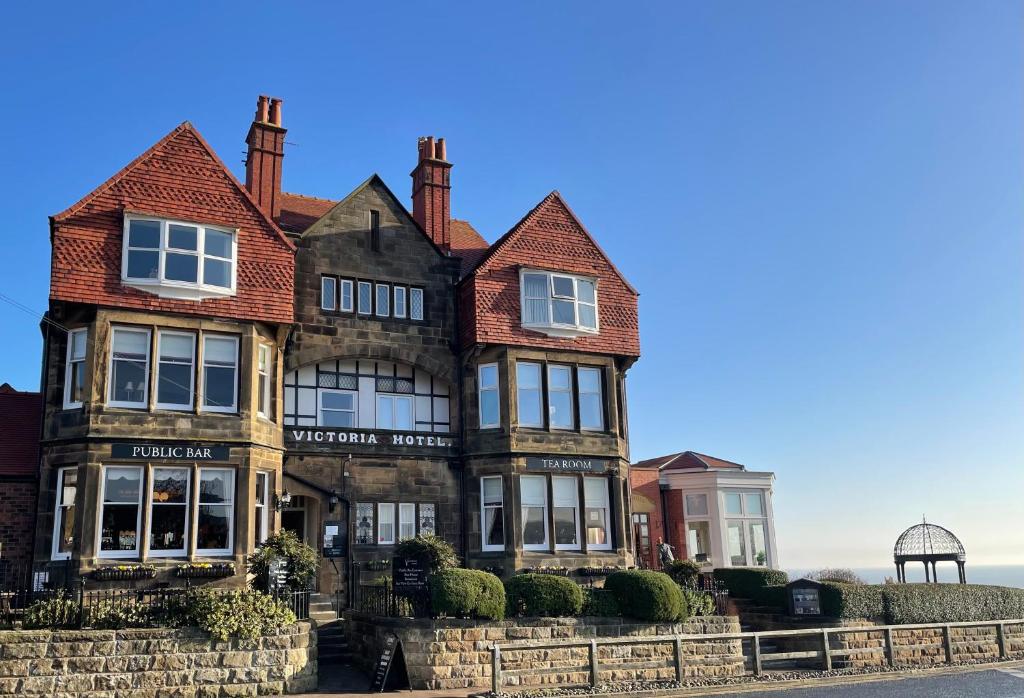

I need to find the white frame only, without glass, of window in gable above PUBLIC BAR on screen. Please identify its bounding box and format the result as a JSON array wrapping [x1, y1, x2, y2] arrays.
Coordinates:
[[121, 214, 239, 300]]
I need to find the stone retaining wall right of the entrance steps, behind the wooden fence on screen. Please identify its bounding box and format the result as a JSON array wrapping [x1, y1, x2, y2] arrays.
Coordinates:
[[345, 612, 743, 690]]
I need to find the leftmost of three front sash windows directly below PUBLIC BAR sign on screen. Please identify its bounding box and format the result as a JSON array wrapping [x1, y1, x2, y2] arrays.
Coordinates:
[[98, 466, 142, 558]]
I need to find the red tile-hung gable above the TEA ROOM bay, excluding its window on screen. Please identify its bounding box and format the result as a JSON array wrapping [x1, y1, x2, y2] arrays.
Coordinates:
[[459, 191, 640, 356]]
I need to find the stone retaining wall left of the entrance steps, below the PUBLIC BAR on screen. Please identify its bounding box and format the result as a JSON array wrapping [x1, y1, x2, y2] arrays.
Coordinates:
[[0, 622, 316, 698]]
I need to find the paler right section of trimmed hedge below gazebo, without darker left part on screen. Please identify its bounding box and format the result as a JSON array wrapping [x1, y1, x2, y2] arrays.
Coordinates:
[[879, 584, 1024, 625]]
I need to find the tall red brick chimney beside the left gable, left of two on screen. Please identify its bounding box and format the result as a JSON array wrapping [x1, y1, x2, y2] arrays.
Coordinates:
[[246, 94, 286, 220]]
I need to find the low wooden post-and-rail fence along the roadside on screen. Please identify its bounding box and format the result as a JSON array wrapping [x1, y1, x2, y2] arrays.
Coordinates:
[[490, 619, 1024, 694]]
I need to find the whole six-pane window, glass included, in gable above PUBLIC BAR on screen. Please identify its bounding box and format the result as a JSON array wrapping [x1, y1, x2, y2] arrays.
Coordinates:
[[121, 216, 238, 300]]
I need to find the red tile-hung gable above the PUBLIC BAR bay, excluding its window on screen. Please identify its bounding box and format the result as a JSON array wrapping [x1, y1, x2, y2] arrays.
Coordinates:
[[50, 122, 295, 322]]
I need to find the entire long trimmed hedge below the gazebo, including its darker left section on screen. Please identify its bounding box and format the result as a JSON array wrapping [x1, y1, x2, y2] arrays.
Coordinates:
[[821, 582, 1024, 625]]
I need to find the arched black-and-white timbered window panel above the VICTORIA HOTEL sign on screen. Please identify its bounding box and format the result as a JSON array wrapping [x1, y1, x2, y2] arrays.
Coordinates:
[[285, 359, 452, 434]]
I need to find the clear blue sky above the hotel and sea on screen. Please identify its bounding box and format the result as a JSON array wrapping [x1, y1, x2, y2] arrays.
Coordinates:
[[0, 0, 1024, 567]]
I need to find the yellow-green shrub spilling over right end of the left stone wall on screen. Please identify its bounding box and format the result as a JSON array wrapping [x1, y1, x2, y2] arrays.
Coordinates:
[[183, 588, 295, 641]]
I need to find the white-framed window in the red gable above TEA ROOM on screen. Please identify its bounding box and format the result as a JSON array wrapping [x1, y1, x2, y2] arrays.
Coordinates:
[[519, 270, 597, 337]]
